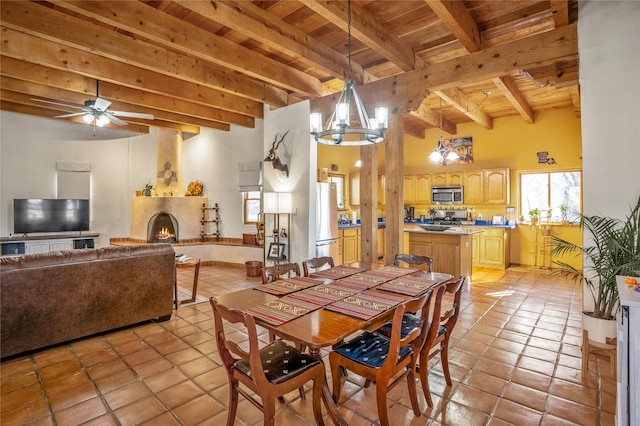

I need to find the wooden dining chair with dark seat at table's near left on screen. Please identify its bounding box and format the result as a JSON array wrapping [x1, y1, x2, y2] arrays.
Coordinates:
[[210, 297, 326, 426]]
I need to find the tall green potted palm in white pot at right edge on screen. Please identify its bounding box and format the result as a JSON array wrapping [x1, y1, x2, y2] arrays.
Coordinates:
[[551, 198, 640, 337]]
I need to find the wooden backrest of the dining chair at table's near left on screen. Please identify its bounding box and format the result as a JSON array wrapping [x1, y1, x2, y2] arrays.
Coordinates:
[[209, 297, 270, 388]]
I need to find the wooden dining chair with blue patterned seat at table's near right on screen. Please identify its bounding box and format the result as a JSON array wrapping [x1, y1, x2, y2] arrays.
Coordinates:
[[329, 293, 431, 426]]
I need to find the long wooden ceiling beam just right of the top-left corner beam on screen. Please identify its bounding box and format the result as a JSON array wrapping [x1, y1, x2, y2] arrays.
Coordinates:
[[52, 1, 324, 96]]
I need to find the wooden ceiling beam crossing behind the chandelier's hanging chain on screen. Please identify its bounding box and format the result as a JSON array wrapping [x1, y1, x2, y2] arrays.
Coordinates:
[[299, 0, 421, 71]]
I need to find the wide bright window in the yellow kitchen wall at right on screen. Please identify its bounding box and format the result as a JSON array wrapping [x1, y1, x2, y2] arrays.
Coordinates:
[[520, 170, 582, 222]]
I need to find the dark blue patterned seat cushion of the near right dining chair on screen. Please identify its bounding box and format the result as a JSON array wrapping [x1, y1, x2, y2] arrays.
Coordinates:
[[335, 331, 411, 367]]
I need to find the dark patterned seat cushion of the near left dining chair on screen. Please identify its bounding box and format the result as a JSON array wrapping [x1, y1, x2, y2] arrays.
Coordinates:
[[235, 340, 322, 384]]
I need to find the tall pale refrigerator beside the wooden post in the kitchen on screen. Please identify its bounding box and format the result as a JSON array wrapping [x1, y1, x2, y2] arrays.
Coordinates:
[[316, 182, 340, 264]]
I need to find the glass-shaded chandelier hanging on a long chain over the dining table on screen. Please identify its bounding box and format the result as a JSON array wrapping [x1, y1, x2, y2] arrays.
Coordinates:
[[310, 0, 389, 146]]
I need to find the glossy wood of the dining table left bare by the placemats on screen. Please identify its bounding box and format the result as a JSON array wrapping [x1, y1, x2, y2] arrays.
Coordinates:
[[216, 262, 453, 425]]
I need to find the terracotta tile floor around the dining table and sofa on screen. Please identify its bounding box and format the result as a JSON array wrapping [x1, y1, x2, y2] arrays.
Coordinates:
[[0, 266, 616, 426]]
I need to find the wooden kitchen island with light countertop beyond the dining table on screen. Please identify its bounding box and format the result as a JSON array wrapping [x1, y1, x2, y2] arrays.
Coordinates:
[[405, 227, 483, 277]]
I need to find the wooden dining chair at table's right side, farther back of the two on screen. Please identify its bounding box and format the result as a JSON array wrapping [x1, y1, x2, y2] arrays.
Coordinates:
[[418, 276, 467, 407]]
